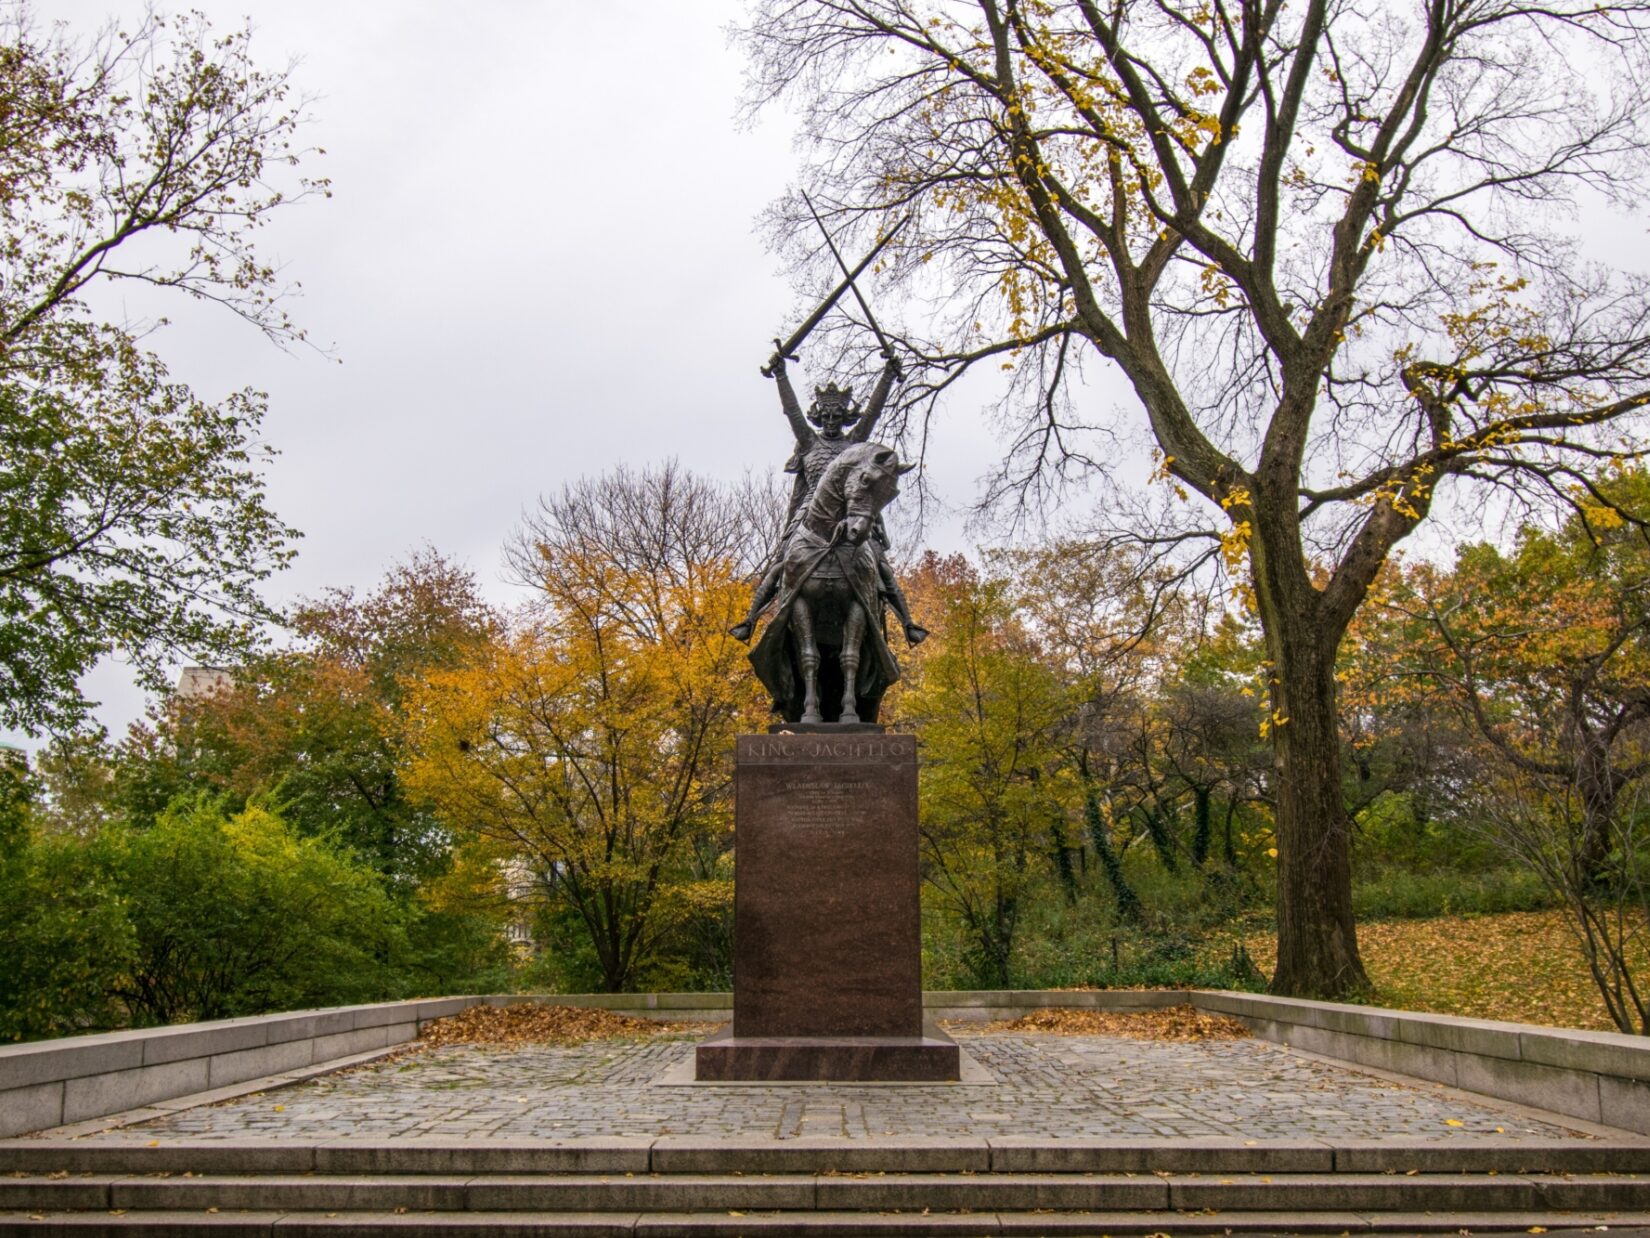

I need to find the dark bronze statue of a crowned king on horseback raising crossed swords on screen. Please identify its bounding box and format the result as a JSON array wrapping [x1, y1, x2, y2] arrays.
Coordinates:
[[729, 203, 927, 725]]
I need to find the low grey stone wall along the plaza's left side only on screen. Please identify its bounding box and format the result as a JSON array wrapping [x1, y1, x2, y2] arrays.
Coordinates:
[[0, 997, 487, 1136]]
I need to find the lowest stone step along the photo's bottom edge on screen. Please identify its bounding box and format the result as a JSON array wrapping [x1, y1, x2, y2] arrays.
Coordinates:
[[0, 1210, 1650, 1238]]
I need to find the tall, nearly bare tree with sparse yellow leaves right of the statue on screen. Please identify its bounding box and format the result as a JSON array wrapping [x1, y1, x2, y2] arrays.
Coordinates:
[[744, 0, 1650, 995]]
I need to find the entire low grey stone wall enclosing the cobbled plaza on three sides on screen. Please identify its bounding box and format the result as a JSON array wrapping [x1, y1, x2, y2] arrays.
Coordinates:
[[0, 989, 1650, 1137]]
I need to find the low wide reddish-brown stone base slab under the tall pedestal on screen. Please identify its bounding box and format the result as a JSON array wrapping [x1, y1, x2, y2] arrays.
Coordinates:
[[695, 1028, 962, 1083]]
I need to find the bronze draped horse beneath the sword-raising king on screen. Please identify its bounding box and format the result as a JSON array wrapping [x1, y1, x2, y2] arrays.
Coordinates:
[[751, 442, 916, 723]]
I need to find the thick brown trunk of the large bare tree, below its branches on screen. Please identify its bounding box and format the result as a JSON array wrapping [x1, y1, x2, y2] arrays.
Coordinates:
[[1254, 524, 1370, 999]]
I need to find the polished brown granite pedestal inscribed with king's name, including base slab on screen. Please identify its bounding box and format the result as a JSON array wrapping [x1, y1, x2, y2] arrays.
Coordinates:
[[696, 726, 959, 1081]]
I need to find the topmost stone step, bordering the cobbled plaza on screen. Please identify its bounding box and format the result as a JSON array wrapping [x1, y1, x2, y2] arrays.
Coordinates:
[[0, 1136, 1650, 1175]]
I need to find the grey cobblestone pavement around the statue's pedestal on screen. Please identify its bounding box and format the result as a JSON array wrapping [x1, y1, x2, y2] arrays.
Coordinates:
[[80, 1033, 1597, 1141]]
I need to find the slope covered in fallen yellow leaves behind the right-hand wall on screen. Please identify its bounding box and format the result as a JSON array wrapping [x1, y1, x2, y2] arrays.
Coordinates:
[[1247, 911, 1636, 1032]]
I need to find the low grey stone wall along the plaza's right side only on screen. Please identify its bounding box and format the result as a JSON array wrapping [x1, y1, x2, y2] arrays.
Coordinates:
[[1186, 992, 1650, 1134]]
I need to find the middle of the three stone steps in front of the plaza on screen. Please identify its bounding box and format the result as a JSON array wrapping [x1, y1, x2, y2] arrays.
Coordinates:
[[0, 1174, 1650, 1213]]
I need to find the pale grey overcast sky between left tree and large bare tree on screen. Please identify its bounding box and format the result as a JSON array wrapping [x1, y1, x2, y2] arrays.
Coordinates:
[[36, 0, 992, 733]]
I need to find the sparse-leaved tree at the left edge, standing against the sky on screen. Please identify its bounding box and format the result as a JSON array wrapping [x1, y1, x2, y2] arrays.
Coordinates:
[[0, 3, 325, 735]]
